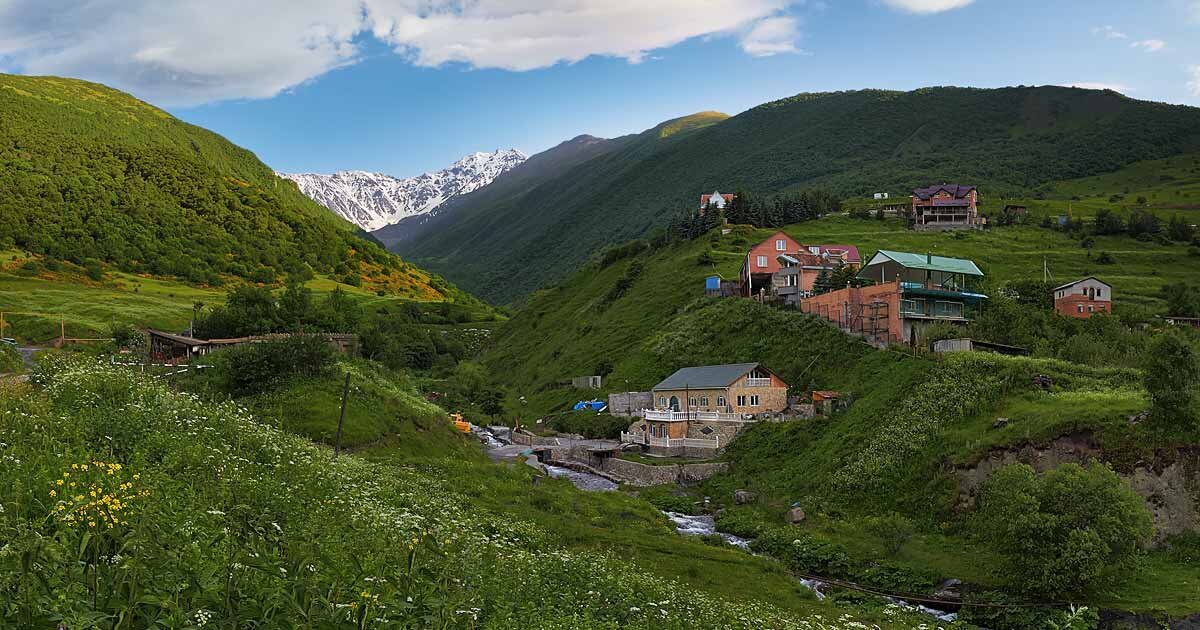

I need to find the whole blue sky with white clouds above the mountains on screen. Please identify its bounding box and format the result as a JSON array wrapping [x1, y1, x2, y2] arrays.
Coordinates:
[[0, 0, 1200, 176]]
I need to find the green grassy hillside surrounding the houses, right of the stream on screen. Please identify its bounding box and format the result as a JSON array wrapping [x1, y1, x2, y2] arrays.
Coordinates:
[[484, 217, 1200, 628]]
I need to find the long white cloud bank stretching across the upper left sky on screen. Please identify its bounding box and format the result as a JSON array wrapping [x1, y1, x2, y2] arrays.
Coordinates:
[[0, 0, 806, 104]]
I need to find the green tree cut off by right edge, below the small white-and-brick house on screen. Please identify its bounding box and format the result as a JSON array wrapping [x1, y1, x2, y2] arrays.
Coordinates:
[[1142, 332, 1200, 428]]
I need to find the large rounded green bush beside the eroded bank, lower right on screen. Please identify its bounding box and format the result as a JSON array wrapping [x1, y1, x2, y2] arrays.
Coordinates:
[[976, 463, 1153, 598]]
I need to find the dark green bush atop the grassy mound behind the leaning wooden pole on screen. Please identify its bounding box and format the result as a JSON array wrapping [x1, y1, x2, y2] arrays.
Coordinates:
[[214, 335, 337, 396]]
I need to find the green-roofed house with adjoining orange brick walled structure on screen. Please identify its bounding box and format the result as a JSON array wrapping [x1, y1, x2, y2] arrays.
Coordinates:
[[800, 250, 988, 346]]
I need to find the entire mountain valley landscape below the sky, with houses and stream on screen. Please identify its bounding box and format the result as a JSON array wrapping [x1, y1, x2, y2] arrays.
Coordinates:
[[0, 74, 1200, 630]]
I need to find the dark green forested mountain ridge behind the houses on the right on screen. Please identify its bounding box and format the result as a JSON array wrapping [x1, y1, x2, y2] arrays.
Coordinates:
[[400, 86, 1200, 302]]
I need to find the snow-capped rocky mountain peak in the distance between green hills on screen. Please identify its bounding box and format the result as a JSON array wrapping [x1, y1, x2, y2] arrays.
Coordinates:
[[280, 149, 526, 232]]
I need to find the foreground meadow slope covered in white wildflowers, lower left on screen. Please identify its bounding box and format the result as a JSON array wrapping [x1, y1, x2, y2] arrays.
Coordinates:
[[0, 357, 940, 629]]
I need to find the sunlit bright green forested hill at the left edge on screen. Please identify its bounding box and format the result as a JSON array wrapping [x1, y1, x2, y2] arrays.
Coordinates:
[[0, 74, 456, 300]]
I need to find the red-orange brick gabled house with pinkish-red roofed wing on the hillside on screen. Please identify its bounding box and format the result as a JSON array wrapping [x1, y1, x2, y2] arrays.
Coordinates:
[[742, 232, 863, 305]]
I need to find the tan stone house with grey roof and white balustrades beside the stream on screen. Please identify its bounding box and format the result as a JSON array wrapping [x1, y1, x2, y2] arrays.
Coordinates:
[[620, 364, 787, 454]]
